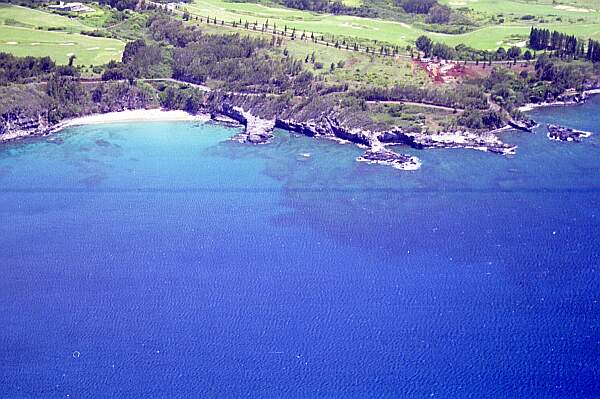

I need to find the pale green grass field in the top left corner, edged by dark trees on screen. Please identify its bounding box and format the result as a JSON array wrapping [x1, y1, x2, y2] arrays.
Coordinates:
[[0, 5, 125, 66]]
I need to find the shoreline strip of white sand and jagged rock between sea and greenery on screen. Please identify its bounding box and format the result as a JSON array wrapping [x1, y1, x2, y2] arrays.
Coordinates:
[[0, 88, 600, 170]]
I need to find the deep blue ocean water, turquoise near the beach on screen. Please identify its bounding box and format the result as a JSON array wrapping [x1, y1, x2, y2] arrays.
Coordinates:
[[0, 97, 600, 398]]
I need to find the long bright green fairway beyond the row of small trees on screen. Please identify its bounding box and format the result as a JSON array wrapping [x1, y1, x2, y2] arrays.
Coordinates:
[[186, 0, 600, 50]]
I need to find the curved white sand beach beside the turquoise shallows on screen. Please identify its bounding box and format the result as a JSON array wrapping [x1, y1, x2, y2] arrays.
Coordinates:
[[52, 109, 210, 132]]
